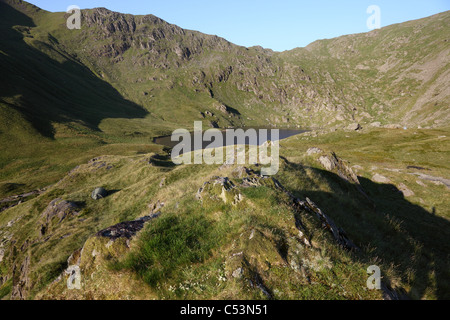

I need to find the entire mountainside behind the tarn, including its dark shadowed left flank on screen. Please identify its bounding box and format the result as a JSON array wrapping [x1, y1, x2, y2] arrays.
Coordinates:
[[0, 0, 450, 140]]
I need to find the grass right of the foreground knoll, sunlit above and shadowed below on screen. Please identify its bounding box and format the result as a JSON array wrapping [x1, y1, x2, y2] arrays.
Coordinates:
[[285, 129, 450, 298]]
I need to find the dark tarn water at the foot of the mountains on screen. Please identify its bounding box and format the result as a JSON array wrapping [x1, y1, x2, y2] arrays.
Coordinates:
[[153, 128, 309, 150]]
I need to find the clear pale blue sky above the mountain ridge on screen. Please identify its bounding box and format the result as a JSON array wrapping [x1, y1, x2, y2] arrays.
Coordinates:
[[29, 0, 450, 51]]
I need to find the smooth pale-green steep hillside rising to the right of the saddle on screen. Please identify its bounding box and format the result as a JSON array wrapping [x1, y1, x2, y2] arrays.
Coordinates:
[[282, 12, 450, 127]]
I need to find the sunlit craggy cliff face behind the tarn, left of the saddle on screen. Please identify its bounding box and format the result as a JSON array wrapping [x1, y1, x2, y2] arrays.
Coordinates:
[[66, 9, 351, 125]]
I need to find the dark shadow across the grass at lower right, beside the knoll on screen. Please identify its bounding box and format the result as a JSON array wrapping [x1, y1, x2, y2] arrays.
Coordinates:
[[282, 163, 450, 299]]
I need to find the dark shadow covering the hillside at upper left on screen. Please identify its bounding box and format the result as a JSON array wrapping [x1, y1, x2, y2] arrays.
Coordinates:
[[0, 2, 148, 138]]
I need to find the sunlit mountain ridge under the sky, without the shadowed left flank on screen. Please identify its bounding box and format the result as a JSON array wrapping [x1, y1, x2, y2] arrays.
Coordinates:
[[1, 1, 449, 136]]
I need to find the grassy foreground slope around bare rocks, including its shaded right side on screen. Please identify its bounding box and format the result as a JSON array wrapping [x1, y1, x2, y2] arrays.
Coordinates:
[[0, 126, 450, 299]]
